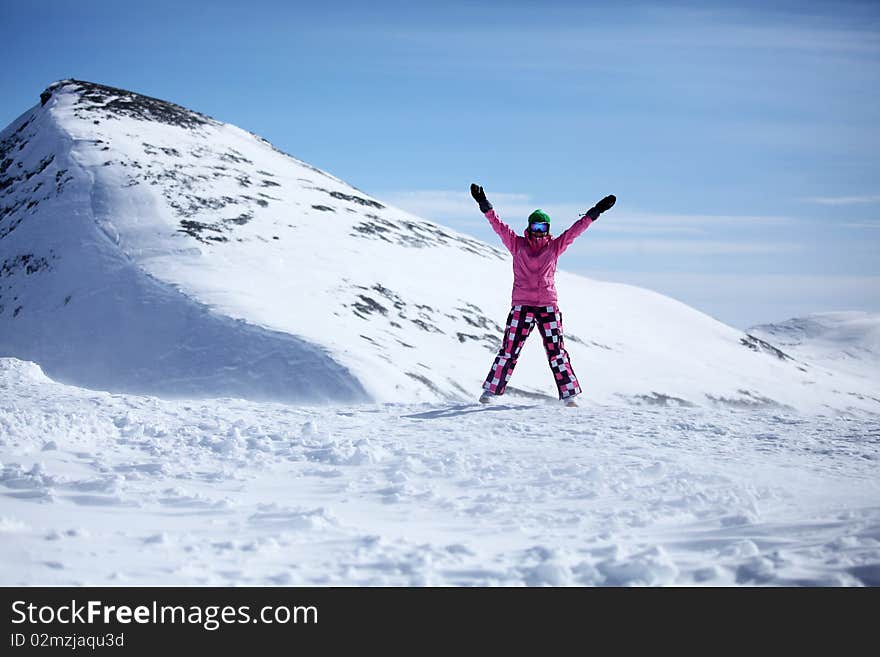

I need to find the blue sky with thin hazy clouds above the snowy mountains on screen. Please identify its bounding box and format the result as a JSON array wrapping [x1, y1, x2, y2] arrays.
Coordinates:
[[0, 0, 880, 328]]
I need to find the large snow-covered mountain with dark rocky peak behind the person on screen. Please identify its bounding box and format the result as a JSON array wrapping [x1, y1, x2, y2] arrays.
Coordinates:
[[0, 80, 880, 411]]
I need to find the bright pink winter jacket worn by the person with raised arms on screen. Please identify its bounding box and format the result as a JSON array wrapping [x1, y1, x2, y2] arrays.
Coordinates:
[[486, 210, 593, 306]]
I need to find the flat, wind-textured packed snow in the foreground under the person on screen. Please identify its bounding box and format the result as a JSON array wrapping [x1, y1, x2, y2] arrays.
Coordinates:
[[0, 359, 880, 586]]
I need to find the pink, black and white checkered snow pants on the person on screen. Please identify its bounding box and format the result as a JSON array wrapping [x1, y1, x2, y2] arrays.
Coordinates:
[[483, 306, 581, 399]]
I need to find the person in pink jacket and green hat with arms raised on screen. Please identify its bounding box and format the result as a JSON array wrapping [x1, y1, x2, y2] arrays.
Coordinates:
[[471, 183, 617, 406]]
